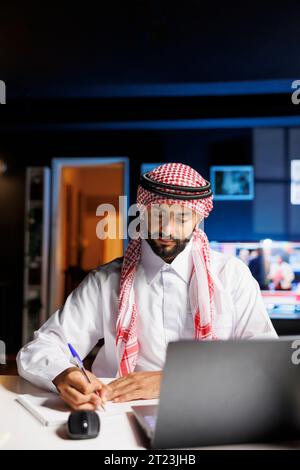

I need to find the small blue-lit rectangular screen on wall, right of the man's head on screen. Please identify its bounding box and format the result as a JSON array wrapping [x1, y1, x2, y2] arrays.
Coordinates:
[[210, 165, 254, 201]]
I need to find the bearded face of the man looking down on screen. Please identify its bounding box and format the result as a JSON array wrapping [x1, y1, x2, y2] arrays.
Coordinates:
[[144, 203, 202, 263]]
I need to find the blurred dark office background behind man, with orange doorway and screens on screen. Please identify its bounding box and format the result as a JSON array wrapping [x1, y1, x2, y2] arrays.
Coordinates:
[[0, 0, 300, 372]]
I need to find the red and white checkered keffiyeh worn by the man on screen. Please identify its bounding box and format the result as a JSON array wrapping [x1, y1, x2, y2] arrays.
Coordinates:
[[116, 163, 215, 376]]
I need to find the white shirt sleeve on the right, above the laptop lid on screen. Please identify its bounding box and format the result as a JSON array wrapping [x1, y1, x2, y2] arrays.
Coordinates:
[[231, 259, 278, 339]]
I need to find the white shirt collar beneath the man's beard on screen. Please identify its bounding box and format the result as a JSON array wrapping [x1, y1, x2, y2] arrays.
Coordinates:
[[141, 239, 193, 284]]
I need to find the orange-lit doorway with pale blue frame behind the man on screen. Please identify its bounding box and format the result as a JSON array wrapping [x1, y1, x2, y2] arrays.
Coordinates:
[[48, 157, 129, 316]]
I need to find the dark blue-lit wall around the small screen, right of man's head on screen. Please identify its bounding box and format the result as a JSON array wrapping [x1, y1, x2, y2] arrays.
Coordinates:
[[165, 128, 300, 241]]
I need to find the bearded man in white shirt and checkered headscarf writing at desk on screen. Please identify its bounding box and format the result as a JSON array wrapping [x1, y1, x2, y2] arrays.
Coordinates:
[[17, 163, 277, 409]]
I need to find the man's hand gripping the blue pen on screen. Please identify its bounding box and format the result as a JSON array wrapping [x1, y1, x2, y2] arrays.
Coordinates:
[[53, 367, 106, 410]]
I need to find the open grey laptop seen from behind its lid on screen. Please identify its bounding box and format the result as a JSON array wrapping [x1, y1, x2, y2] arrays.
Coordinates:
[[132, 337, 300, 448]]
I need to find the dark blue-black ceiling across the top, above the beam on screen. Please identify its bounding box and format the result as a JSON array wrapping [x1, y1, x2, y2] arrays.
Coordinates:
[[0, 0, 300, 96]]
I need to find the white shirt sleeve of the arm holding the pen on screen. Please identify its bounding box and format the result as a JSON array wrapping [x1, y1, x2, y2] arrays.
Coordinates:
[[17, 271, 103, 391]]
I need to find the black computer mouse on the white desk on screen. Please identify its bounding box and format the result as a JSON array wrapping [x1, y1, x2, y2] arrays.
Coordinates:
[[67, 411, 100, 439]]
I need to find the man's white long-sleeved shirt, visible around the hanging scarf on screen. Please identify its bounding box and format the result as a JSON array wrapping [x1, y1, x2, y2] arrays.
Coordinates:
[[17, 240, 277, 391]]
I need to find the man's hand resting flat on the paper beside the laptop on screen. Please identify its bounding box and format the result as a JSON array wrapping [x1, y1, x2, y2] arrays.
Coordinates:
[[101, 371, 162, 402]]
